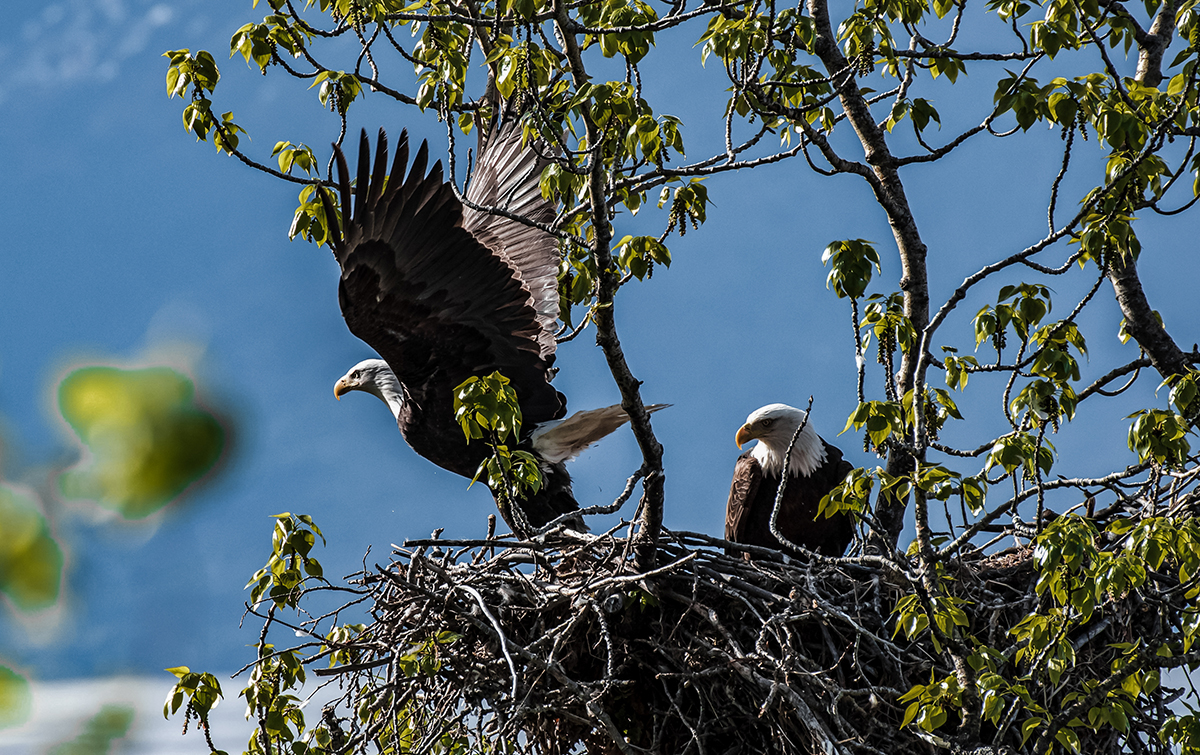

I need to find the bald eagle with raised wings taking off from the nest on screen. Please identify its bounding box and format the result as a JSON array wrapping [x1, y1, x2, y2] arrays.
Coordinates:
[[319, 120, 662, 535]]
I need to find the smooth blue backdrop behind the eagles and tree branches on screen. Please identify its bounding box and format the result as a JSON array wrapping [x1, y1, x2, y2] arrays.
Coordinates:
[[0, 0, 1198, 679]]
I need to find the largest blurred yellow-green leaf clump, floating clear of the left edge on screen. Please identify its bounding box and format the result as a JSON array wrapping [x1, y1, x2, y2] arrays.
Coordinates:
[[59, 367, 224, 519]]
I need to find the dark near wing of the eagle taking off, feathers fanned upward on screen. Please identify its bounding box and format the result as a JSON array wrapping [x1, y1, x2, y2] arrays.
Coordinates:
[[320, 130, 565, 423]]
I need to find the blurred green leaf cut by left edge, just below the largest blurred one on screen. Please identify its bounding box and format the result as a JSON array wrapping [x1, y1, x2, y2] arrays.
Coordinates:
[[0, 484, 62, 612]]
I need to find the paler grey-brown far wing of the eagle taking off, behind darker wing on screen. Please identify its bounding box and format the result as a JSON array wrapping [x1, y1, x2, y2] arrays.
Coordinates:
[[462, 118, 558, 358]]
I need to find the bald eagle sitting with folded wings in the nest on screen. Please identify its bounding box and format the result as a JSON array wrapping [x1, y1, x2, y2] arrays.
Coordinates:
[[725, 403, 854, 556]]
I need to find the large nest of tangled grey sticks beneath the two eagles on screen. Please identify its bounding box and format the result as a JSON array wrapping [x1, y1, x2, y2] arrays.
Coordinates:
[[295, 511, 1185, 755]]
